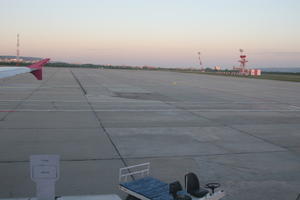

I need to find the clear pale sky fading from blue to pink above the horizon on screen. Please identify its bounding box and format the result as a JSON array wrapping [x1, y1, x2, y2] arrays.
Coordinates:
[[0, 0, 300, 68]]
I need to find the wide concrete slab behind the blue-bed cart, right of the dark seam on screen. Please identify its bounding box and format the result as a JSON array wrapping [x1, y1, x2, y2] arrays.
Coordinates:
[[107, 127, 287, 157]]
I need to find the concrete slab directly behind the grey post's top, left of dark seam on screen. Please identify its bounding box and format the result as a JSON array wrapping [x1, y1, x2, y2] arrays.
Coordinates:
[[0, 128, 119, 162]]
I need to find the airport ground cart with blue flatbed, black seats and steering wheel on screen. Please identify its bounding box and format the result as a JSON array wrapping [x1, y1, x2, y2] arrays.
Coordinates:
[[119, 163, 225, 200]]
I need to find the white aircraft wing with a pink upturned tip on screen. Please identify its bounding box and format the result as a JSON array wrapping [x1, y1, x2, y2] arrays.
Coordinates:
[[0, 58, 50, 80]]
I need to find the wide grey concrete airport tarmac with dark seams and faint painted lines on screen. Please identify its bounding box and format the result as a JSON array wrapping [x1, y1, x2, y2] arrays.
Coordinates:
[[0, 68, 300, 200]]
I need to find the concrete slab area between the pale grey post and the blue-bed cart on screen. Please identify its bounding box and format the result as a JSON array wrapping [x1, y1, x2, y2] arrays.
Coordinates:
[[57, 160, 124, 197]]
